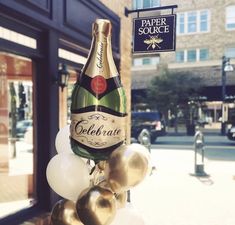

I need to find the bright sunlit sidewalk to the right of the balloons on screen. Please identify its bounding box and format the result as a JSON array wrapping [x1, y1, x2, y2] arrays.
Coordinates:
[[131, 149, 235, 225]]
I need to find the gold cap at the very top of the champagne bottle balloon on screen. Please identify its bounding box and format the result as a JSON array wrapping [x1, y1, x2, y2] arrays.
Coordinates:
[[93, 19, 112, 37]]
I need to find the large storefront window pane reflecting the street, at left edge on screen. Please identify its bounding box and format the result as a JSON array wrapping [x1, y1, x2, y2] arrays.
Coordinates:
[[0, 52, 36, 218]]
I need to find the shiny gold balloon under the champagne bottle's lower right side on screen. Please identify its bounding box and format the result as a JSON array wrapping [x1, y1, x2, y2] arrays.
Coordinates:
[[104, 144, 150, 193]]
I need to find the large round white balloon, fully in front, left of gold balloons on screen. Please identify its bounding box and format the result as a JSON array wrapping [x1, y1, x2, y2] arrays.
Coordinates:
[[46, 153, 90, 201]]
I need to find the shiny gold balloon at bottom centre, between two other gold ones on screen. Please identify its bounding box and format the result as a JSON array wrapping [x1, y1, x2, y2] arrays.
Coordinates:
[[76, 186, 116, 225]]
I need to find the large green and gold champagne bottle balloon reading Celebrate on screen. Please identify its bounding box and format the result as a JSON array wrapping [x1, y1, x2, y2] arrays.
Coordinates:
[[70, 19, 126, 161]]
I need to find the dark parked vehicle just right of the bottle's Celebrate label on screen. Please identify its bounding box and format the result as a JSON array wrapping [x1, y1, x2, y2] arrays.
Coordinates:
[[131, 111, 166, 143]]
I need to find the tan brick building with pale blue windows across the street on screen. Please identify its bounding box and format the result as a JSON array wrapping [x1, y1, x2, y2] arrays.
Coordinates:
[[132, 0, 235, 127]]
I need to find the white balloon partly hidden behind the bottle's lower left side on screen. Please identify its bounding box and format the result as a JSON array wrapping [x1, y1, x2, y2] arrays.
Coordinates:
[[55, 125, 73, 153]]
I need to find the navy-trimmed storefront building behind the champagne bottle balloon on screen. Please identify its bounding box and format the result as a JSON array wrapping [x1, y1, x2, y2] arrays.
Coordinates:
[[0, 0, 131, 225]]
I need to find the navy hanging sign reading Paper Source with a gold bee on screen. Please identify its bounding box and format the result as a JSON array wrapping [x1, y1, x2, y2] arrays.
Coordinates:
[[133, 14, 176, 53]]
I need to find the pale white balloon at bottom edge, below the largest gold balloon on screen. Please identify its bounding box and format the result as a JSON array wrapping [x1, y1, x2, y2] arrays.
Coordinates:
[[110, 203, 145, 225]]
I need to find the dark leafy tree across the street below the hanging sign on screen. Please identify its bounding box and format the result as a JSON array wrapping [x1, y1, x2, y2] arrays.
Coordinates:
[[147, 69, 202, 132]]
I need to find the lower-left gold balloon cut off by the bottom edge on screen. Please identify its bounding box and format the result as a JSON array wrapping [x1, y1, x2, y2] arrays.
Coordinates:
[[50, 200, 83, 225]]
